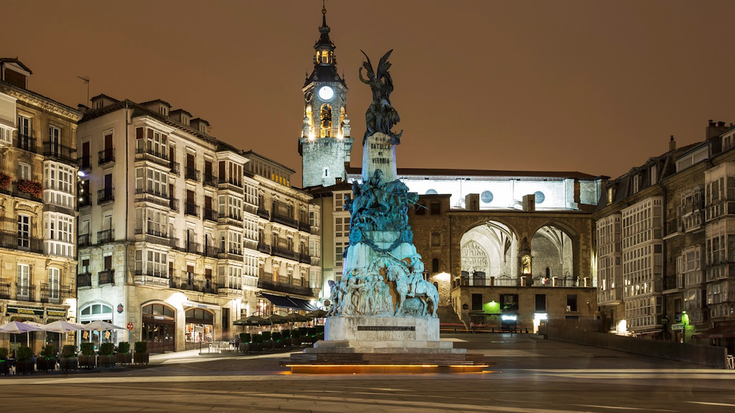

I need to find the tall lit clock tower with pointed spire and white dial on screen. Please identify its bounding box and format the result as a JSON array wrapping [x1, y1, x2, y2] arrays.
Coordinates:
[[299, 8, 353, 188]]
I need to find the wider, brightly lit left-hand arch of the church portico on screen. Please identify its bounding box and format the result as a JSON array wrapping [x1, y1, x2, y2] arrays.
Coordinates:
[[459, 221, 518, 286]]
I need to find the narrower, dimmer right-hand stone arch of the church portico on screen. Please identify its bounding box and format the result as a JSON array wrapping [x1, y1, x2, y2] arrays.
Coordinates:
[[531, 225, 578, 287]]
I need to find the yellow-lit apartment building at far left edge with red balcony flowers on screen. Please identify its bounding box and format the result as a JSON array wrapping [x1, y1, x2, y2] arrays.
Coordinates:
[[0, 58, 82, 352]]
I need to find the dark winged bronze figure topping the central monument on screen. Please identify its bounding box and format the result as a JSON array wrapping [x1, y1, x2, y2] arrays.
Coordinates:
[[358, 49, 403, 145]]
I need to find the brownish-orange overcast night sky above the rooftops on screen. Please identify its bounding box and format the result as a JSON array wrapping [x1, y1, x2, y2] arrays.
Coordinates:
[[0, 0, 735, 186]]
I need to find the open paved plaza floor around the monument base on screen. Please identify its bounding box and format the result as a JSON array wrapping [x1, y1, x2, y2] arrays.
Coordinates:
[[0, 334, 735, 413]]
